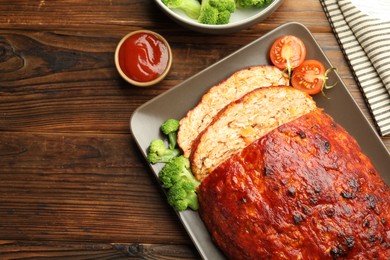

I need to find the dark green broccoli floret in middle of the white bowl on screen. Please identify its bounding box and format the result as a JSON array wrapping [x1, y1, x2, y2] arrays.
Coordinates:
[[198, 0, 236, 24]]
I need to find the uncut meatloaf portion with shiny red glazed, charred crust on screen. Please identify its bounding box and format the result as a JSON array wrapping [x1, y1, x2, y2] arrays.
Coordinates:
[[198, 109, 390, 259]]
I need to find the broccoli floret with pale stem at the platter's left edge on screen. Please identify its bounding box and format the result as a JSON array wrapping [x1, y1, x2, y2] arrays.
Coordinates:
[[146, 139, 180, 164]]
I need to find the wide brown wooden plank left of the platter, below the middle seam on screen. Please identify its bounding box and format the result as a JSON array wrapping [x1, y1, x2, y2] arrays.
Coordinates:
[[0, 132, 191, 244]]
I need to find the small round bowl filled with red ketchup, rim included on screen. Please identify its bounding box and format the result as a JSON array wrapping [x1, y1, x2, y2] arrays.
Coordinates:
[[115, 30, 172, 87]]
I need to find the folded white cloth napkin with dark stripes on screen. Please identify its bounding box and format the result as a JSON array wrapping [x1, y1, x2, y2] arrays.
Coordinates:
[[320, 0, 390, 136]]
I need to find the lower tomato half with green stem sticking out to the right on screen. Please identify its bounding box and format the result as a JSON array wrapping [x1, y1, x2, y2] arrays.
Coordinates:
[[291, 60, 326, 95]]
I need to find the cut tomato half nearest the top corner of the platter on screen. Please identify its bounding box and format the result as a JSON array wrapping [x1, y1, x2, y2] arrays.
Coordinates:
[[270, 35, 306, 72]]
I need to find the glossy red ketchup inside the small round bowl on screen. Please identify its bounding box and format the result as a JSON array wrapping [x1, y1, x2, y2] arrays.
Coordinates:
[[118, 32, 169, 82]]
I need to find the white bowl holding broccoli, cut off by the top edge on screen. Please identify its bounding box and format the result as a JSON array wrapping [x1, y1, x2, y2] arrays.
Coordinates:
[[155, 0, 283, 34]]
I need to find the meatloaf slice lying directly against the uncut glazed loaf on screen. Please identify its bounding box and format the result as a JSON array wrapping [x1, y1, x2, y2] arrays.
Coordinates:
[[190, 87, 316, 181]]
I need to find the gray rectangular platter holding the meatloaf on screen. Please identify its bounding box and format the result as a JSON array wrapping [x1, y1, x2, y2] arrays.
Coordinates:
[[130, 23, 390, 260]]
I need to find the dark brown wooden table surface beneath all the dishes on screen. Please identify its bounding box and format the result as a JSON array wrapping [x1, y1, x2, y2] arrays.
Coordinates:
[[0, 0, 390, 259]]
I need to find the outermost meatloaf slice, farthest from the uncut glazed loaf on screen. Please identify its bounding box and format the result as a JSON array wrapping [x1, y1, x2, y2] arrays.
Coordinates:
[[177, 65, 289, 157]]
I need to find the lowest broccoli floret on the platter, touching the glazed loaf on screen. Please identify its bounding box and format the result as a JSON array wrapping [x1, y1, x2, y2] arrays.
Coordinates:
[[167, 181, 198, 211]]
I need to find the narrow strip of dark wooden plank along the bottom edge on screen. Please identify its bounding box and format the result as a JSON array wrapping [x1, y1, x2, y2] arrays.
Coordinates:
[[0, 240, 200, 260]]
